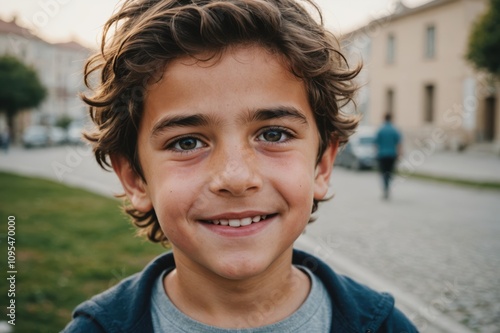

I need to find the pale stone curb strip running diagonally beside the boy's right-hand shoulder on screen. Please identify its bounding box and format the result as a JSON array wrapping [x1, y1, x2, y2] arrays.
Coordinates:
[[295, 235, 473, 333]]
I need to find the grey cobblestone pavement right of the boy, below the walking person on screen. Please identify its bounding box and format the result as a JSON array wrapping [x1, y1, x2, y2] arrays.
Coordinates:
[[307, 168, 500, 332]]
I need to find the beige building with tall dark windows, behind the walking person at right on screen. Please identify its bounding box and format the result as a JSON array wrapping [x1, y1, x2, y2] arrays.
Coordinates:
[[344, 0, 500, 149]]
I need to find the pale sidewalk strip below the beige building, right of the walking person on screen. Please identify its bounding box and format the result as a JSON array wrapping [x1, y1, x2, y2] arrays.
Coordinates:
[[398, 149, 500, 184]]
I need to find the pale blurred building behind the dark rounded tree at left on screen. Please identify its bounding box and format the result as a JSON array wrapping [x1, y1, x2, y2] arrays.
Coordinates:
[[0, 18, 91, 138]]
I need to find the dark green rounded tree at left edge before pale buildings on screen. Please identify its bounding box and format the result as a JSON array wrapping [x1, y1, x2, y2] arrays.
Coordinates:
[[0, 55, 47, 139]]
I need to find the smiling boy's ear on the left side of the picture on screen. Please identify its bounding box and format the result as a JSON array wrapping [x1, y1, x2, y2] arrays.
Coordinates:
[[111, 156, 153, 213]]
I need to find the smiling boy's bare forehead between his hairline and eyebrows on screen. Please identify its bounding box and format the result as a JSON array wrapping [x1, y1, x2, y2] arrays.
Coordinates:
[[139, 46, 312, 128]]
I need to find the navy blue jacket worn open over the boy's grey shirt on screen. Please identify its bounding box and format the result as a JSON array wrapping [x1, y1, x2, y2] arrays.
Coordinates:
[[63, 250, 417, 333]]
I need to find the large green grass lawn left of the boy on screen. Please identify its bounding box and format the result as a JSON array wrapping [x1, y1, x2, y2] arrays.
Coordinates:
[[0, 173, 165, 333]]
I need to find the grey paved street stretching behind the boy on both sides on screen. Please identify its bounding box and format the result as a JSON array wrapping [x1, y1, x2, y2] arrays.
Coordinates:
[[0, 146, 500, 332]]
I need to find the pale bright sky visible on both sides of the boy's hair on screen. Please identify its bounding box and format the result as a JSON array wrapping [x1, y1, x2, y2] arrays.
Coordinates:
[[0, 0, 429, 47]]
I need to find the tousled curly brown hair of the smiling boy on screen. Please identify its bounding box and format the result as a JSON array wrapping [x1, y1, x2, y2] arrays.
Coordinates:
[[82, 0, 361, 243]]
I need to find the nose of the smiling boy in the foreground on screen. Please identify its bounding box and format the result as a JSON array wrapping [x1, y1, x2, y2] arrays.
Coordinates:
[[210, 147, 262, 196]]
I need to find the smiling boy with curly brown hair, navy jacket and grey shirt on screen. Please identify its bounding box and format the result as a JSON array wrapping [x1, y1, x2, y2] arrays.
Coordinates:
[[65, 0, 416, 332]]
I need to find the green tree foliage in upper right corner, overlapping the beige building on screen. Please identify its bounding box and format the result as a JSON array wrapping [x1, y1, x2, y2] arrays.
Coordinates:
[[466, 0, 500, 78]]
